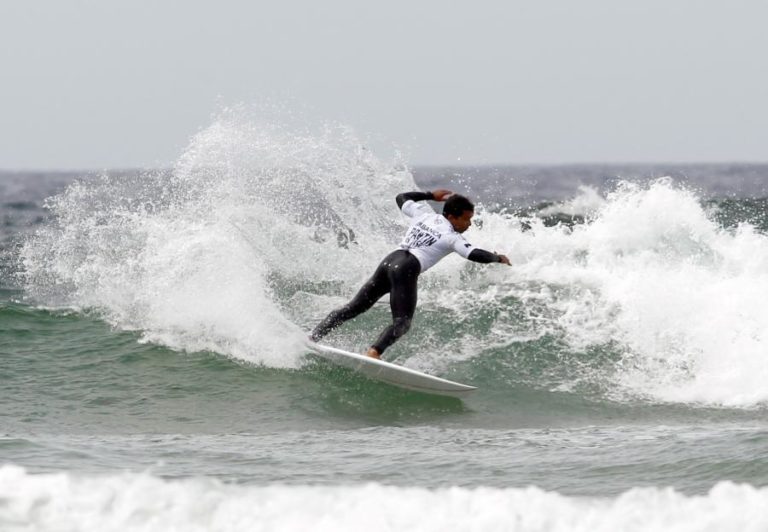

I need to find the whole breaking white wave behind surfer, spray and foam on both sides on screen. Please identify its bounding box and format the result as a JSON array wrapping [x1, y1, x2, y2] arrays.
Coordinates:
[[20, 108, 768, 408]]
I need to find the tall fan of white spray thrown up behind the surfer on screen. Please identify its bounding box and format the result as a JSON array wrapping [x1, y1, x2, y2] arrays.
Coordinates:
[[21, 107, 415, 367]]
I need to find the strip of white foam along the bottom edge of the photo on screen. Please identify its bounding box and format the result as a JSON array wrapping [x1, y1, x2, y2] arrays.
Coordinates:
[[0, 465, 768, 532]]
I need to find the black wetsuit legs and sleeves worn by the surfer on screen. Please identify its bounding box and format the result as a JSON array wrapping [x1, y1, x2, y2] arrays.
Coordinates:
[[310, 192, 499, 354]]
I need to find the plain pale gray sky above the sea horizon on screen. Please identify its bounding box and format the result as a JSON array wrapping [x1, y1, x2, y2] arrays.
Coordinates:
[[0, 0, 768, 169]]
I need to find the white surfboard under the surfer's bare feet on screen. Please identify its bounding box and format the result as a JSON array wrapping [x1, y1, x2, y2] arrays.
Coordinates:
[[307, 343, 477, 397]]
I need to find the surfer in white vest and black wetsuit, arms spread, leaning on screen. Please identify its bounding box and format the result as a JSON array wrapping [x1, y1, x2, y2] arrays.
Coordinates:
[[309, 189, 509, 358]]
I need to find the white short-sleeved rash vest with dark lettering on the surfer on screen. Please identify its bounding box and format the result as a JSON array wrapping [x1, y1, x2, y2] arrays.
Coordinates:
[[400, 200, 475, 273]]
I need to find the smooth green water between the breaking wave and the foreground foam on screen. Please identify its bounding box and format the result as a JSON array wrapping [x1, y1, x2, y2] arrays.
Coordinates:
[[0, 286, 768, 495]]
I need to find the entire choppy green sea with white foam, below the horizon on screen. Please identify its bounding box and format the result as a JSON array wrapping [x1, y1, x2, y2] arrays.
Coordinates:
[[0, 110, 768, 531]]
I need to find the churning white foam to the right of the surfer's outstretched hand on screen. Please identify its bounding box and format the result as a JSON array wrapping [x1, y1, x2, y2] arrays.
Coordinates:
[[452, 179, 768, 406]]
